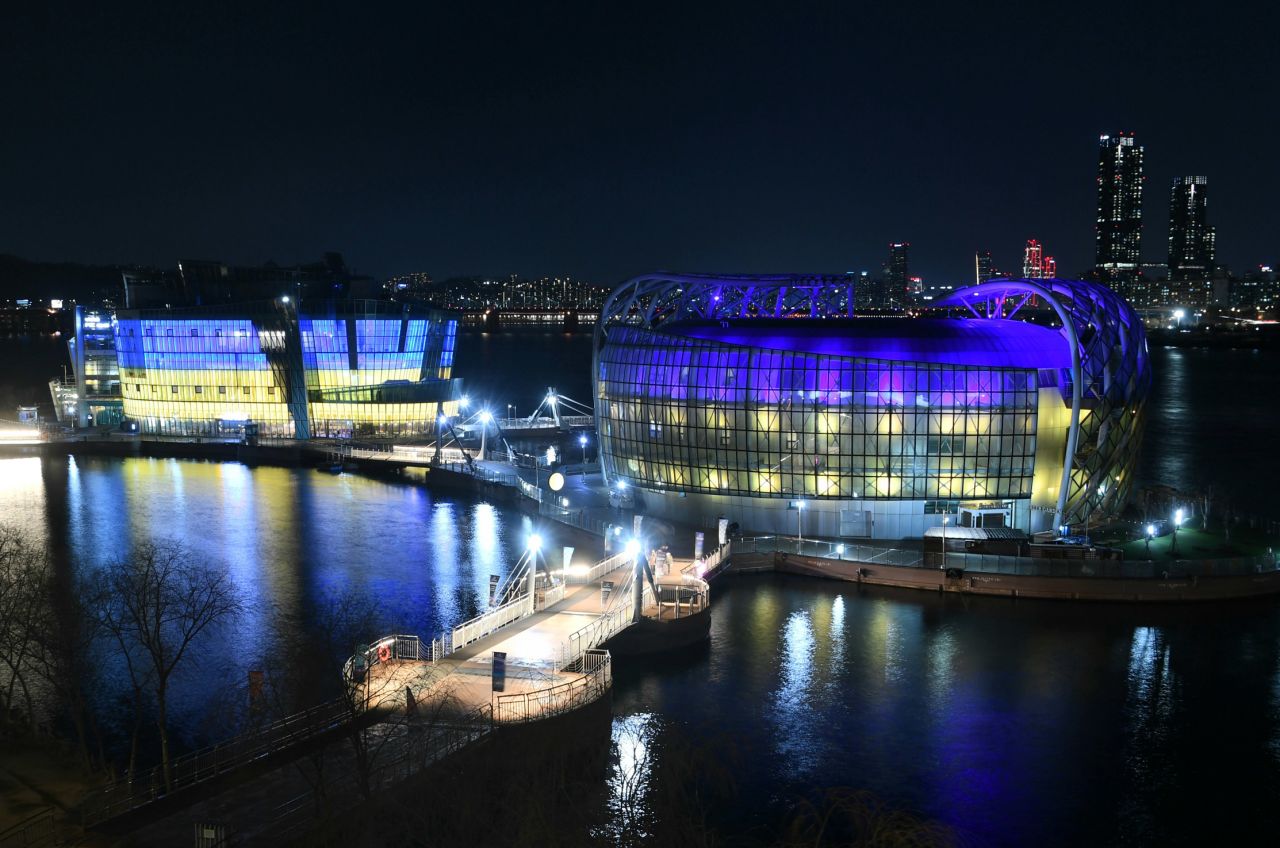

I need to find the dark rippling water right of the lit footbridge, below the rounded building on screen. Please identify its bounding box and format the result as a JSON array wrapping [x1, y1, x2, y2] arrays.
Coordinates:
[[614, 576, 1280, 845]]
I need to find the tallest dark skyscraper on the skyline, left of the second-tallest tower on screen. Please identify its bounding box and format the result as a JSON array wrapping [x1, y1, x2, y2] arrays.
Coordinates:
[[1096, 133, 1143, 296]]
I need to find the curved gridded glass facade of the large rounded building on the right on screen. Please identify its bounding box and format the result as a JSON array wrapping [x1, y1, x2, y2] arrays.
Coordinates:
[[596, 327, 1038, 501]]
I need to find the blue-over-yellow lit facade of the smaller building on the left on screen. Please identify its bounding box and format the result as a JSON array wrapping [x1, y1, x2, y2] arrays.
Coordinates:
[[115, 297, 461, 438]]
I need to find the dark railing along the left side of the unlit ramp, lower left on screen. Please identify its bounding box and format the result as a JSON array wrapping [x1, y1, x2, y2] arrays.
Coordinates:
[[79, 696, 353, 826]]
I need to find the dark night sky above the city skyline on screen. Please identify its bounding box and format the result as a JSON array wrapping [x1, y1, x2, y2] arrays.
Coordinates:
[[0, 3, 1280, 282]]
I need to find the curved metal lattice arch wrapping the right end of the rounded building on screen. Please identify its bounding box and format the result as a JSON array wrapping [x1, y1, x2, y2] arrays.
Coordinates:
[[937, 279, 1151, 524]]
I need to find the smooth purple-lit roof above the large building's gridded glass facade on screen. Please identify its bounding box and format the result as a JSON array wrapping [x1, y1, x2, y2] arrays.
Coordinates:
[[662, 318, 1071, 368]]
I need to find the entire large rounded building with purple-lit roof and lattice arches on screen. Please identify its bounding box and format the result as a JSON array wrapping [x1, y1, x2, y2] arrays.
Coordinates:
[[593, 274, 1151, 538]]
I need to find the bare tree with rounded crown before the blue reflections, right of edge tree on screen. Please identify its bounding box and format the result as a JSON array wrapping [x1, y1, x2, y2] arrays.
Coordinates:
[[100, 541, 243, 790]]
